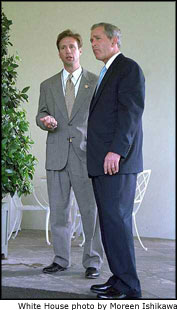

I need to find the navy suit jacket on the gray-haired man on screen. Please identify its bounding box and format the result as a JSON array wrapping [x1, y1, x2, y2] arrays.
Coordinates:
[[87, 54, 145, 176]]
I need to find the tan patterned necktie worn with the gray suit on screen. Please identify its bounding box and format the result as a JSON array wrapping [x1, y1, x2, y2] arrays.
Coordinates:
[[65, 74, 75, 117]]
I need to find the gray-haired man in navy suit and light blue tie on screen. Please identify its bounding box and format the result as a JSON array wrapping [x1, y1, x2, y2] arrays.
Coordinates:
[[87, 23, 145, 299]]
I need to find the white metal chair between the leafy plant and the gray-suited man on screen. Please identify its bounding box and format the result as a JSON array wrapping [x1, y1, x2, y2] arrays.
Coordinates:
[[8, 190, 51, 245]]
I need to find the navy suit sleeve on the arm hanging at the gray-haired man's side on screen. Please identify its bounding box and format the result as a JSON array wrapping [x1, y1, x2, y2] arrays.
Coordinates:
[[110, 63, 145, 158]]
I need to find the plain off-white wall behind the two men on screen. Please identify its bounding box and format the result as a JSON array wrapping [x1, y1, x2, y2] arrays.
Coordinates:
[[2, 1, 175, 239]]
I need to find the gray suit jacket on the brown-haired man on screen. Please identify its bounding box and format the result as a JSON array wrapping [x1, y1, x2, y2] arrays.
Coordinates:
[[36, 70, 98, 170]]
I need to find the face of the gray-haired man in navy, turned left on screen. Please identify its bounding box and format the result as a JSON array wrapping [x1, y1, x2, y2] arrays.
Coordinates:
[[90, 26, 115, 63]]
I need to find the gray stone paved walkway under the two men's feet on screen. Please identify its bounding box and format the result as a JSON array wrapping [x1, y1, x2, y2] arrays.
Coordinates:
[[1, 230, 176, 299]]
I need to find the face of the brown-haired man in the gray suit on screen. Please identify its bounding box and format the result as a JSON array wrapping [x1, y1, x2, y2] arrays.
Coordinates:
[[59, 37, 82, 67]]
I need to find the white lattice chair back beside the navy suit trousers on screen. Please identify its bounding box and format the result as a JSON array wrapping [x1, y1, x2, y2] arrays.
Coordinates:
[[133, 169, 151, 214]]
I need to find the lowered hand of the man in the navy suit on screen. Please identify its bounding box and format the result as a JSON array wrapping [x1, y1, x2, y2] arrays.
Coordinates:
[[104, 152, 120, 175]]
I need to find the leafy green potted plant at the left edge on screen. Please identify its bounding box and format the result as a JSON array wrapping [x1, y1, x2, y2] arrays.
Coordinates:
[[1, 11, 37, 256]]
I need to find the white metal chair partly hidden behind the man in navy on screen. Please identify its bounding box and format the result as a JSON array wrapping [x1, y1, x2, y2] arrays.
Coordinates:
[[132, 169, 151, 251]]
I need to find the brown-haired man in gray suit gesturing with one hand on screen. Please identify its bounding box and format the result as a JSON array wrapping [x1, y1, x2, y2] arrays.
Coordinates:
[[36, 30, 103, 279]]
